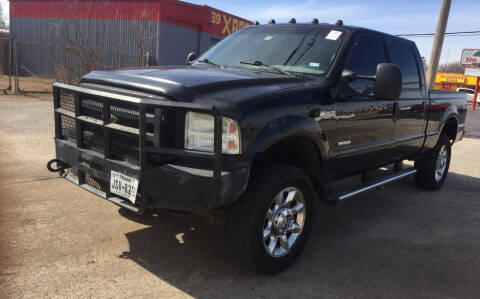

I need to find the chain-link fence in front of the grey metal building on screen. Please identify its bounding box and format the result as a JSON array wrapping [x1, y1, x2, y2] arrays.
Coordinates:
[[11, 41, 151, 93]]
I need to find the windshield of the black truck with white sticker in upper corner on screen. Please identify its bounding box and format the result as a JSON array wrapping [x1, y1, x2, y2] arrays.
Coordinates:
[[194, 25, 345, 75]]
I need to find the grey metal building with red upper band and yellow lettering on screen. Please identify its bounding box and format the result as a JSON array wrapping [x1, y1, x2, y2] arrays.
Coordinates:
[[10, 0, 251, 79]]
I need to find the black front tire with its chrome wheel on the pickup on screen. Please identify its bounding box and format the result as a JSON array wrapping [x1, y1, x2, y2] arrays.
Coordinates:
[[227, 163, 314, 274]]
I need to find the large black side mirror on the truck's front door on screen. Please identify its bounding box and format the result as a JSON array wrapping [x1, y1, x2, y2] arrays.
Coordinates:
[[374, 63, 402, 100]]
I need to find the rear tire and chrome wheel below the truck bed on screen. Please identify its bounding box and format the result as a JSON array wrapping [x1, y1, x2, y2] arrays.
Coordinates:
[[415, 134, 452, 190]]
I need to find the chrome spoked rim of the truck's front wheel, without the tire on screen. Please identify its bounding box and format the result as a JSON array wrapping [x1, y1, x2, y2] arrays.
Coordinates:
[[263, 187, 305, 257]]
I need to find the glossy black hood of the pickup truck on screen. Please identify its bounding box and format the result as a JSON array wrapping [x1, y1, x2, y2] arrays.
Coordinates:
[[82, 66, 311, 102]]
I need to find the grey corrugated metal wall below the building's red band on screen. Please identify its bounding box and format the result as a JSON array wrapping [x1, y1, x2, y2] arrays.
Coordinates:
[[11, 18, 222, 77]]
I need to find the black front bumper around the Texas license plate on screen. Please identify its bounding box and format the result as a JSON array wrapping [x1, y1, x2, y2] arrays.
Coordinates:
[[55, 140, 249, 214]]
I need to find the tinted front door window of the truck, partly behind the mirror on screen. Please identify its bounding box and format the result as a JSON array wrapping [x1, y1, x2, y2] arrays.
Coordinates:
[[345, 35, 387, 93]]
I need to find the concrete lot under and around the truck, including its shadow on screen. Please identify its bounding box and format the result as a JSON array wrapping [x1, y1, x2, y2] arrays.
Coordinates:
[[0, 95, 480, 298]]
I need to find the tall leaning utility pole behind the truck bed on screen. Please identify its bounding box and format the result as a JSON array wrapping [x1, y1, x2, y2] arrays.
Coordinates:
[[427, 0, 452, 89]]
